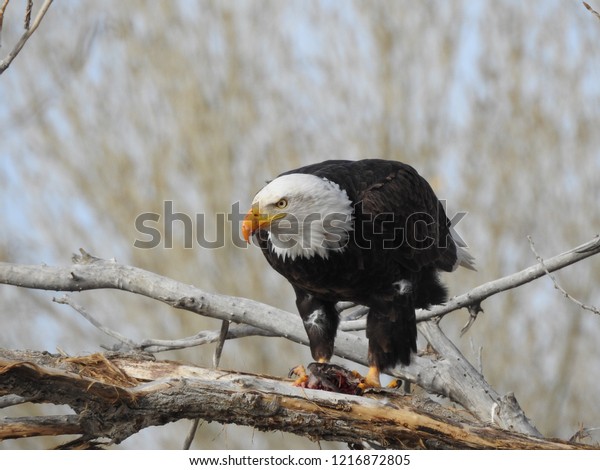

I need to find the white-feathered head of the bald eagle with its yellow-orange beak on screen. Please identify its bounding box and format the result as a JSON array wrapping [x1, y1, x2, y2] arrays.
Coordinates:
[[242, 173, 353, 260]]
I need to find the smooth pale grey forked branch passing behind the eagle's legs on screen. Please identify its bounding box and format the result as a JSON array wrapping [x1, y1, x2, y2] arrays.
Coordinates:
[[0, 237, 600, 442]]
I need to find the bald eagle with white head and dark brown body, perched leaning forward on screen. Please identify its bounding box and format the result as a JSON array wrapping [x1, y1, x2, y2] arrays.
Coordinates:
[[242, 159, 474, 387]]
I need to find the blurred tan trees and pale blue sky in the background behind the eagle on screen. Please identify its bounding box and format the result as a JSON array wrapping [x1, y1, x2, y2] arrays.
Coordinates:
[[0, 0, 600, 449]]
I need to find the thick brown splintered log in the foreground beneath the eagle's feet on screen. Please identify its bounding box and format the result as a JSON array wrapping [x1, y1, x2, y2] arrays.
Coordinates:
[[0, 349, 590, 449]]
